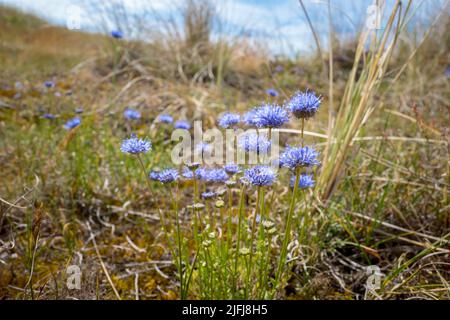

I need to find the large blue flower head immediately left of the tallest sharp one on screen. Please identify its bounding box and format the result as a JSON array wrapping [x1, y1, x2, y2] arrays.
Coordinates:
[[251, 104, 289, 128]]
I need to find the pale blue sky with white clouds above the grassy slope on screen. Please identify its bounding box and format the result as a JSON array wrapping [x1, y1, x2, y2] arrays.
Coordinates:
[[0, 0, 446, 55]]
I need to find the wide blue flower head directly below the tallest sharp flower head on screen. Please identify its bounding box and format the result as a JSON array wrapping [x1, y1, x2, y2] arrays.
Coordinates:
[[280, 146, 319, 170]]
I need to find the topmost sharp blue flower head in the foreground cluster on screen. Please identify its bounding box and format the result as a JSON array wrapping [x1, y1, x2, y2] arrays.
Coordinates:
[[286, 90, 322, 119]]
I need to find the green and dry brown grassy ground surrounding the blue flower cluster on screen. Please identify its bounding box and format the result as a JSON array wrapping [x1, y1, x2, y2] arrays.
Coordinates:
[[0, 3, 450, 299]]
